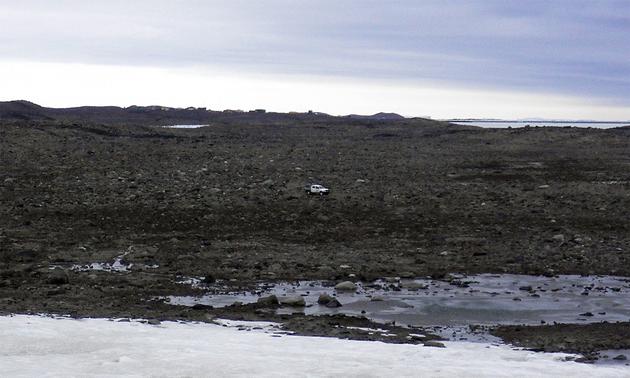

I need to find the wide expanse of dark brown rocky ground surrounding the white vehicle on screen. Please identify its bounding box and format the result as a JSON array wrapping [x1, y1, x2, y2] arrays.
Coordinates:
[[0, 116, 630, 356]]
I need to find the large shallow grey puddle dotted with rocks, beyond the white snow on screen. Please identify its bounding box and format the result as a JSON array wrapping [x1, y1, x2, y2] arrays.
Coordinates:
[[166, 274, 630, 327]]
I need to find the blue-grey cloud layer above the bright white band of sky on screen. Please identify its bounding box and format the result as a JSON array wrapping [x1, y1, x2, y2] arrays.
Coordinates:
[[0, 0, 630, 115]]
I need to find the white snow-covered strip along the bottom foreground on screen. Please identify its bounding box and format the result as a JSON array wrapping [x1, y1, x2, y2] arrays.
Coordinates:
[[0, 315, 629, 378]]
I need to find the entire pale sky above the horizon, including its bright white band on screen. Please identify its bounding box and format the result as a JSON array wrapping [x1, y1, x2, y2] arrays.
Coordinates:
[[0, 0, 630, 120]]
